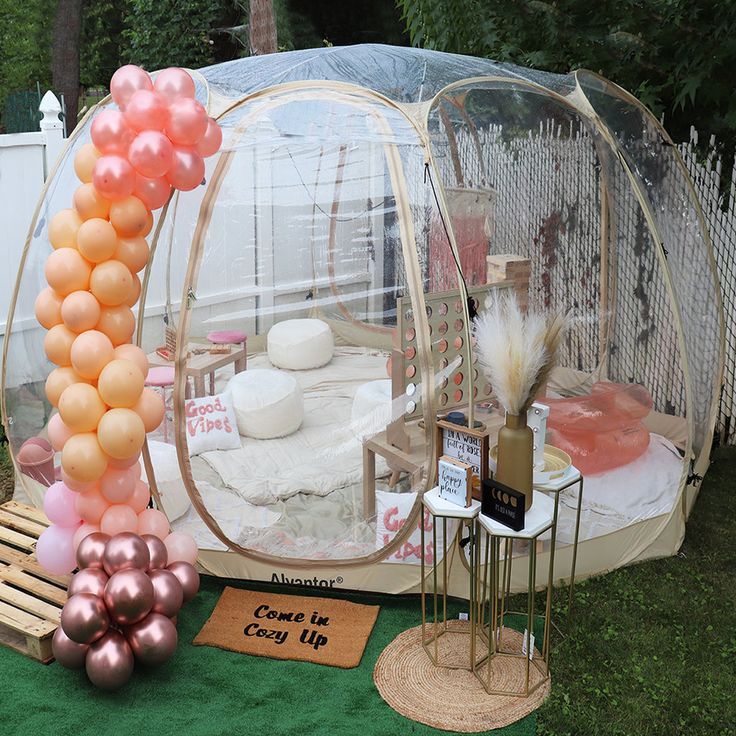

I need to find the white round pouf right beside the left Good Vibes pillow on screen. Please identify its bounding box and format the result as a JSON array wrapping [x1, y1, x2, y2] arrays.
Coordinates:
[[227, 368, 304, 440]]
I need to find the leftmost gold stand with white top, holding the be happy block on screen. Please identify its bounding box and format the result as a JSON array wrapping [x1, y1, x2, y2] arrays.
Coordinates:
[[420, 487, 480, 670]]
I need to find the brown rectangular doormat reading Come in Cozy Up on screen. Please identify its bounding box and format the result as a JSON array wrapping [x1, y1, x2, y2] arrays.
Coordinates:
[[193, 587, 380, 669]]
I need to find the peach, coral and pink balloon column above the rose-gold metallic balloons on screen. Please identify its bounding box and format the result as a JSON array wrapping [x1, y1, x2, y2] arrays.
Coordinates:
[[35, 65, 222, 574]]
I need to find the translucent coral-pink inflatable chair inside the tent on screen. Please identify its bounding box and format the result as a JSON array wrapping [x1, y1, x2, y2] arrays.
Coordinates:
[[544, 383, 652, 475]]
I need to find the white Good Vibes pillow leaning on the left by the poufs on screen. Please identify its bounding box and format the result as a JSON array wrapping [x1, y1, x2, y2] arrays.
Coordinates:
[[184, 394, 241, 457]]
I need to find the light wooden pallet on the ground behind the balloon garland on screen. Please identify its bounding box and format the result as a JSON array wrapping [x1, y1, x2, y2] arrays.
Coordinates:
[[0, 501, 70, 664]]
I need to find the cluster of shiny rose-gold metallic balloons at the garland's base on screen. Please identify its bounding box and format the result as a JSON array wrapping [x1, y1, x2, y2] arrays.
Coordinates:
[[52, 532, 199, 690]]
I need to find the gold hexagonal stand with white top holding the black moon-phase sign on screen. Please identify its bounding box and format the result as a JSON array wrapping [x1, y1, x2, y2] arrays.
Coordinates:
[[473, 491, 556, 697]]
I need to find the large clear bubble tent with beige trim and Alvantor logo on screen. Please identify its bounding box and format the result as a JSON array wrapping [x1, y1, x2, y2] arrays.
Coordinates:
[[2, 45, 723, 595]]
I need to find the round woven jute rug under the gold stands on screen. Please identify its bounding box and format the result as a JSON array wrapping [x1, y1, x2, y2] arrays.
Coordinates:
[[373, 622, 551, 733]]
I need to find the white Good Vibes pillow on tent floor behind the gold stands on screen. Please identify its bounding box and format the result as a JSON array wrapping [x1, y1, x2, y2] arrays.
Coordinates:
[[376, 491, 446, 565]]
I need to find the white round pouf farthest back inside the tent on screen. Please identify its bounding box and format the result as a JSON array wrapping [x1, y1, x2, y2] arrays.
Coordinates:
[[268, 319, 335, 371]]
